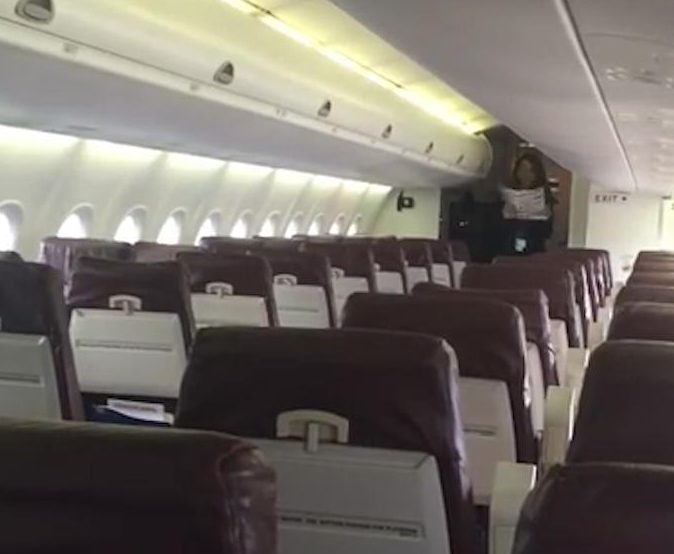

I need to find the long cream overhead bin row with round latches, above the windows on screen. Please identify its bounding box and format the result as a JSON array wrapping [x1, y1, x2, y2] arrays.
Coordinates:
[[0, 0, 491, 186]]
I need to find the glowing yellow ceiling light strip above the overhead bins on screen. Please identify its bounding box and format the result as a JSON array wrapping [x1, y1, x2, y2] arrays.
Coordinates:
[[221, 0, 472, 134]]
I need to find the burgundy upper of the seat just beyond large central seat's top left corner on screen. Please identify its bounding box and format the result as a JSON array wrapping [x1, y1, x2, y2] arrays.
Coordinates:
[[177, 252, 278, 326]]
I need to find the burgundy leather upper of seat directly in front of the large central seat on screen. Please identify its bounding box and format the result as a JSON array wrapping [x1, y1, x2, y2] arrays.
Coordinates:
[[342, 294, 536, 462]]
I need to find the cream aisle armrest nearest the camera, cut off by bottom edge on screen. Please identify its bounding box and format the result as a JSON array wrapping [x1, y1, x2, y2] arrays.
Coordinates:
[[489, 462, 536, 554]]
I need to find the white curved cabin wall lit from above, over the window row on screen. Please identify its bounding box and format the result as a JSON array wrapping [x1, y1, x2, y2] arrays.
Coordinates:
[[0, 126, 391, 259]]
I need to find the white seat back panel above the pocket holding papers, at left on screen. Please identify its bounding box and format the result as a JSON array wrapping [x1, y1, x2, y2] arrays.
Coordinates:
[[70, 309, 187, 398]]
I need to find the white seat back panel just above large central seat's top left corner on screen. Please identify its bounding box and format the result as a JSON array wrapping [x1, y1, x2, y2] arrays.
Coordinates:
[[192, 293, 269, 329]]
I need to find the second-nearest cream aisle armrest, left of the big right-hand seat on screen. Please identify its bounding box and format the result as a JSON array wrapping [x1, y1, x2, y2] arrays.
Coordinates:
[[540, 387, 576, 471]]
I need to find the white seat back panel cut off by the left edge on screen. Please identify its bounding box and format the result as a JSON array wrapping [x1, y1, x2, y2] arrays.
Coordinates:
[[0, 333, 61, 419]]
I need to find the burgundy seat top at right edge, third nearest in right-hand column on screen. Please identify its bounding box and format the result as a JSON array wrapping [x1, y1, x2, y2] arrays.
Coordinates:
[[608, 302, 674, 341]]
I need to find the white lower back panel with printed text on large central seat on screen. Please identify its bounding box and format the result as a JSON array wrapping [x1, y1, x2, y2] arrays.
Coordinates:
[[249, 440, 449, 554]]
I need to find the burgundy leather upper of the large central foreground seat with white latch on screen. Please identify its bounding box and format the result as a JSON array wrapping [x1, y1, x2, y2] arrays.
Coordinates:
[[176, 328, 476, 554]]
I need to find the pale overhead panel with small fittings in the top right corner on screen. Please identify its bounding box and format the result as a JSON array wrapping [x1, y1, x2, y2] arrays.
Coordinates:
[[570, 0, 674, 193]]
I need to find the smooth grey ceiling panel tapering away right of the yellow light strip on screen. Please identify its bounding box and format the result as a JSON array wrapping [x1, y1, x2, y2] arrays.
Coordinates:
[[333, 0, 636, 190]]
